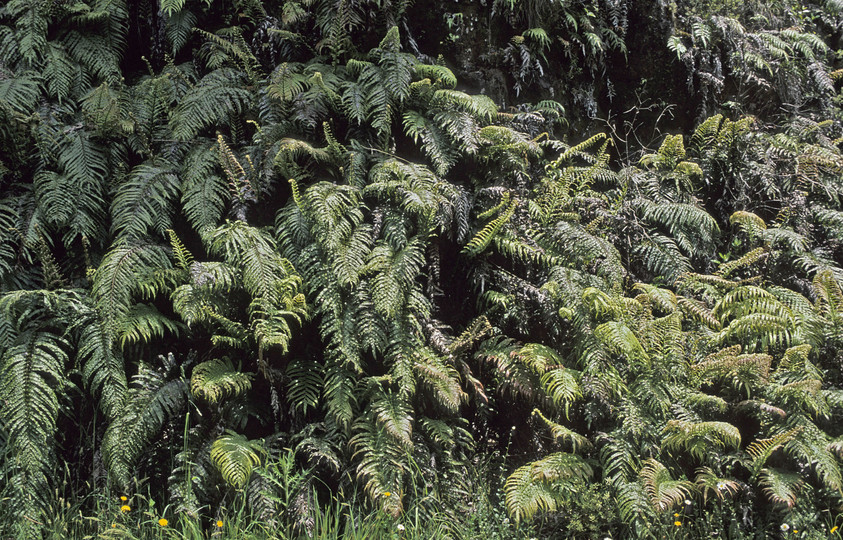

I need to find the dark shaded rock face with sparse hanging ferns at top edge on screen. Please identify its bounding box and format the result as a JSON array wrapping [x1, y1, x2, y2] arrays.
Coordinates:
[[398, 0, 701, 137]]
